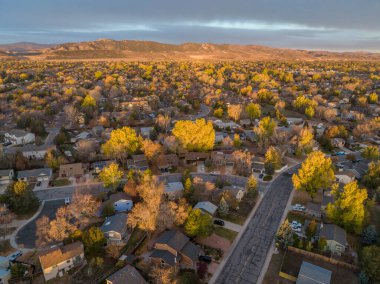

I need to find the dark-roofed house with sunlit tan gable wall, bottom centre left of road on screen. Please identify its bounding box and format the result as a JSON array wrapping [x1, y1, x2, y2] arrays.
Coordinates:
[[150, 230, 201, 268]]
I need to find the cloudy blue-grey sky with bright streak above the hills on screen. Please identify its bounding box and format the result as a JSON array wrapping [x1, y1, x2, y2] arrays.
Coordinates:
[[0, 0, 380, 52]]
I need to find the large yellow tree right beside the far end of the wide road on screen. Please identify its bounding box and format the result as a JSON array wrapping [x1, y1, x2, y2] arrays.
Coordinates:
[[292, 151, 335, 199]]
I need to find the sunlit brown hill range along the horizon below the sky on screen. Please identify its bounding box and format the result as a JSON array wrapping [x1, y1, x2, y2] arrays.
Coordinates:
[[0, 39, 380, 61]]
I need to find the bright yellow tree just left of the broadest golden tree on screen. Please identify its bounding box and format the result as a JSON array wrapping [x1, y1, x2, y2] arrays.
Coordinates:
[[102, 126, 141, 162]]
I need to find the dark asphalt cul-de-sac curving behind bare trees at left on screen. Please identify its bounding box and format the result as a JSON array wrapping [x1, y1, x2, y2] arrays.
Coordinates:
[[15, 199, 65, 249]]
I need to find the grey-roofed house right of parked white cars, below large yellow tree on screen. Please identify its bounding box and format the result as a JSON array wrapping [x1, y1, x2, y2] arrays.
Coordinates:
[[319, 224, 347, 255]]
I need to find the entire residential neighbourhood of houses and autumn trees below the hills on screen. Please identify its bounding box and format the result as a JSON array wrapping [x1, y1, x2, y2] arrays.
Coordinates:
[[0, 58, 380, 284]]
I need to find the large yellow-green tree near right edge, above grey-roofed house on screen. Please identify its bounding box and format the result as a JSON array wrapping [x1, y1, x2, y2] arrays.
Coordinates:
[[326, 181, 368, 233]]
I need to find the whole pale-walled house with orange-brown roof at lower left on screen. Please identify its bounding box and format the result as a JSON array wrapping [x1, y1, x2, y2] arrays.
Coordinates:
[[38, 242, 84, 281]]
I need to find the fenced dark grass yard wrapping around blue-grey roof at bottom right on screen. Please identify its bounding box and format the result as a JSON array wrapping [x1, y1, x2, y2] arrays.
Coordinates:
[[281, 251, 359, 284]]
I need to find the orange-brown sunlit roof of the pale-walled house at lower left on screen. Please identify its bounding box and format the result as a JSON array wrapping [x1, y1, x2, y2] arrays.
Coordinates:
[[39, 242, 84, 269]]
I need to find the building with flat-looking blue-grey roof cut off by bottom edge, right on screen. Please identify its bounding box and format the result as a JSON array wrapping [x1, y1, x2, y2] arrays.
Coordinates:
[[296, 261, 332, 284]]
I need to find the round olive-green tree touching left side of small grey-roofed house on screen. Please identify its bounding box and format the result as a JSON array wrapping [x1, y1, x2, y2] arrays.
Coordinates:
[[185, 208, 212, 238]]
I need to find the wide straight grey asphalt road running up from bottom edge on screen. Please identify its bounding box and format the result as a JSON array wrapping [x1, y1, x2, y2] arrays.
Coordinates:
[[215, 172, 293, 284]]
